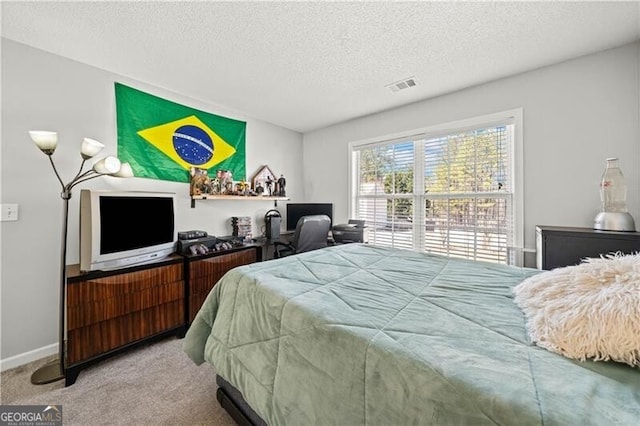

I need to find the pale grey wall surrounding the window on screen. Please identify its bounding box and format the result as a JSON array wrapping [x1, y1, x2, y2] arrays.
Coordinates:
[[303, 42, 640, 266]]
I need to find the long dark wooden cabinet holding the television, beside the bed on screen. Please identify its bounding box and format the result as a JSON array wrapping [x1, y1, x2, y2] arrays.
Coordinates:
[[65, 245, 262, 386]]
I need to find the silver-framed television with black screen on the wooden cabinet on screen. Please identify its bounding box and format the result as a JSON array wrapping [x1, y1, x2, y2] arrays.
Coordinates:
[[80, 189, 177, 271]]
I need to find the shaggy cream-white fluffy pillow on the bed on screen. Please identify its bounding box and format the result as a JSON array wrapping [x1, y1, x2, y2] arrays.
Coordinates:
[[513, 253, 640, 366]]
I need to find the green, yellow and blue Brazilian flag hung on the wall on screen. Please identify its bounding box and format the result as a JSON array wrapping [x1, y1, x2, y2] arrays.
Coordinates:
[[115, 83, 247, 182]]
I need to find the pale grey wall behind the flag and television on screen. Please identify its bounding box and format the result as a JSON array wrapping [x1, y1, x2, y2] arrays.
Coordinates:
[[0, 38, 304, 369]]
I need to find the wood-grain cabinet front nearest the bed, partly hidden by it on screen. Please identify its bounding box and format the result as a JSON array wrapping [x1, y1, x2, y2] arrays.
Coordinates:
[[189, 249, 257, 323]]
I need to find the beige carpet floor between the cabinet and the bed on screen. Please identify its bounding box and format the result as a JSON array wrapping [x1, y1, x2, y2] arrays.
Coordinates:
[[0, 338, 235, 426]]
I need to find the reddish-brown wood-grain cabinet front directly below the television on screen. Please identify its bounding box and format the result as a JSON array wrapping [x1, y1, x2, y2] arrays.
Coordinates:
[[67, 263, 185, 364]]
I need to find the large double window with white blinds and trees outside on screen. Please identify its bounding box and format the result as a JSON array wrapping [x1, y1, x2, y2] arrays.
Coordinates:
[[350, 110, 522, 263]]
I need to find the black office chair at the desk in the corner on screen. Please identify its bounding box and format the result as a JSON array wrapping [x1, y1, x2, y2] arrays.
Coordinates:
[[273, 214, 331, 259]]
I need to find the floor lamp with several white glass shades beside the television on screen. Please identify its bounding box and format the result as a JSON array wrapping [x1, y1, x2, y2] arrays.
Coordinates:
[[29, 130, 133, 385]]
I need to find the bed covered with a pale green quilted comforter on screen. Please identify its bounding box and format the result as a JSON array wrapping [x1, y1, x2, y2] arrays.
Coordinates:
[[183, 244, 640, 425]]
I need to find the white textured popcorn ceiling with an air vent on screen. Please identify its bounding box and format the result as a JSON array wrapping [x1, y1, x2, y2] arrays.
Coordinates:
[[1, 1, 640, 132]]
